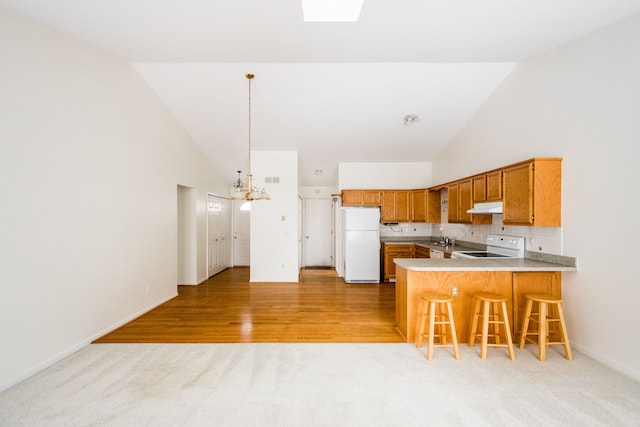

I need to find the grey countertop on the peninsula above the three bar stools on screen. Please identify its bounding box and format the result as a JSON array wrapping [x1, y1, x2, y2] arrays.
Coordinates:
[[393, 258, 578, 271]]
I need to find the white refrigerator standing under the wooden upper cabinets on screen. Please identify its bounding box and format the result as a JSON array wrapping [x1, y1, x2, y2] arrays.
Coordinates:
[[342, 207, 380, 283]]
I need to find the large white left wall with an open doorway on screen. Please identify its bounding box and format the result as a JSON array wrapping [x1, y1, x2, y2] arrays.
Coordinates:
[[0, 8, 228, 390]]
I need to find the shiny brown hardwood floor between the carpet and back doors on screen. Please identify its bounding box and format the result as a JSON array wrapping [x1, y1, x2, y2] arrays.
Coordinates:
[[95, 267, 403, 343]]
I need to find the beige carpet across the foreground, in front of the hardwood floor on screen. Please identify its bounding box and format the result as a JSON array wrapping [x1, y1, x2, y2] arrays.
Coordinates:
[[0, 344, 640, 427]]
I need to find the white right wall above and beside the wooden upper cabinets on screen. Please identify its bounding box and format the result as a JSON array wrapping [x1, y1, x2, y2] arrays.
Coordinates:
[[434, 15, 640, 379]]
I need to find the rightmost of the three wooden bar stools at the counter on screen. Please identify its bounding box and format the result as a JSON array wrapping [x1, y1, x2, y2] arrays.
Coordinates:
[[519, 294, 573, 362]]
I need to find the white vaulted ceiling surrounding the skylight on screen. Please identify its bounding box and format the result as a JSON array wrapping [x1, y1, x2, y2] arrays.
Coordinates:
[[0, 0, 640, 186]]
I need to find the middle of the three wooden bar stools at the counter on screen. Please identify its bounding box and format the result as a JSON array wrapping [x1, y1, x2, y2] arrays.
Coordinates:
[[469, 292, 515, 360]]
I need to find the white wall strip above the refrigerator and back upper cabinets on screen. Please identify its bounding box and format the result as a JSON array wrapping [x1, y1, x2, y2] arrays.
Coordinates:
[[338, 163, 432, 190]]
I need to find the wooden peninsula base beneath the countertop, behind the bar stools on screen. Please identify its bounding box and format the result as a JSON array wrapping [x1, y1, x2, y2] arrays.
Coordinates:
[[396, 267, 562, 342]]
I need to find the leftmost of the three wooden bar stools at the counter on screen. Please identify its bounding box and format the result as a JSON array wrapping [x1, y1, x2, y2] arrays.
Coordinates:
[[416, 293, 460, 360]]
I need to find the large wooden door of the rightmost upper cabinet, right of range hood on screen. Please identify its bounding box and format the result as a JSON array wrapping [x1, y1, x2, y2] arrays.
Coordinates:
[[502, 162, 533, 225]]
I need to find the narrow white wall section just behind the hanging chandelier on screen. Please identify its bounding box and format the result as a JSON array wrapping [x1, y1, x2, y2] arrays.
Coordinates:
[[250, 151, 301, 282]]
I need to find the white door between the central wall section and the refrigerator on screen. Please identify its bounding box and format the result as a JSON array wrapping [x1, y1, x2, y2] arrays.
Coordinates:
[[304, 199, 334, 267]]
